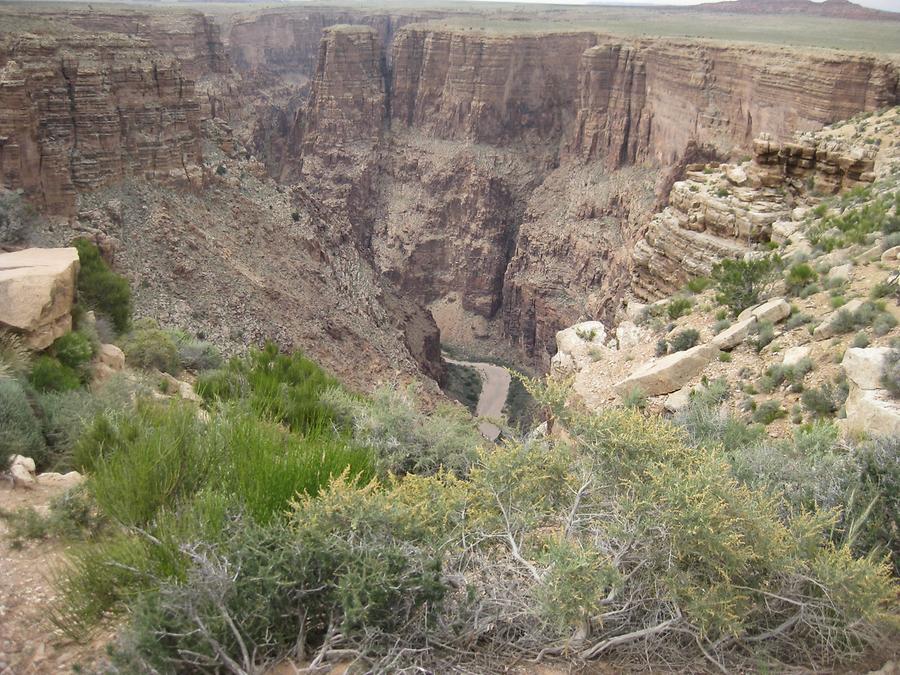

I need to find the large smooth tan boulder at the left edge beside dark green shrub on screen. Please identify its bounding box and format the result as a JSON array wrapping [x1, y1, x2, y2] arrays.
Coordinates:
[[0, 248, 78, 350]]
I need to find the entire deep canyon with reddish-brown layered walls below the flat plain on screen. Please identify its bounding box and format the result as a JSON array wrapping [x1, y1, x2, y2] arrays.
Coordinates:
[[0, 5, 900, 383]]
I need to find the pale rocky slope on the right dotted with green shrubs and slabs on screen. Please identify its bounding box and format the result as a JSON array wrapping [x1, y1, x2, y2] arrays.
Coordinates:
[[553, 108, 900, 436]]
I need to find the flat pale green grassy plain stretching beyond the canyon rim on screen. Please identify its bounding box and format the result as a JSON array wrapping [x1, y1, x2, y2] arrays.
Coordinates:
[[0, 0, 900, 58]]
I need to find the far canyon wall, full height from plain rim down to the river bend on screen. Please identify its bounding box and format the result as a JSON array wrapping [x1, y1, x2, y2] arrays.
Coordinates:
[[294, 24, 898, 364]]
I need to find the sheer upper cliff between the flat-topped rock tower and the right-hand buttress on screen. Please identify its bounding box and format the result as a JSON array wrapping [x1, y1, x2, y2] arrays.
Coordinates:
[[391, 28, 597, 144]]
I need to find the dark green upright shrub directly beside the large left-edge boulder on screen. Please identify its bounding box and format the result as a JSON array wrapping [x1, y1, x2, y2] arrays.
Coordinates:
[[72, 239, 131, 333]]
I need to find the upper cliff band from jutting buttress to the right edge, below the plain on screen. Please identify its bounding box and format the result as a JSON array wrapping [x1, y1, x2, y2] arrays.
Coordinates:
[[571, 40, 898, 167]]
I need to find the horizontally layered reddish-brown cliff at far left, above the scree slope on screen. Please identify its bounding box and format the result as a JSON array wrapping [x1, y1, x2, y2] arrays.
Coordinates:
[[0, 34, 201, 213]]
